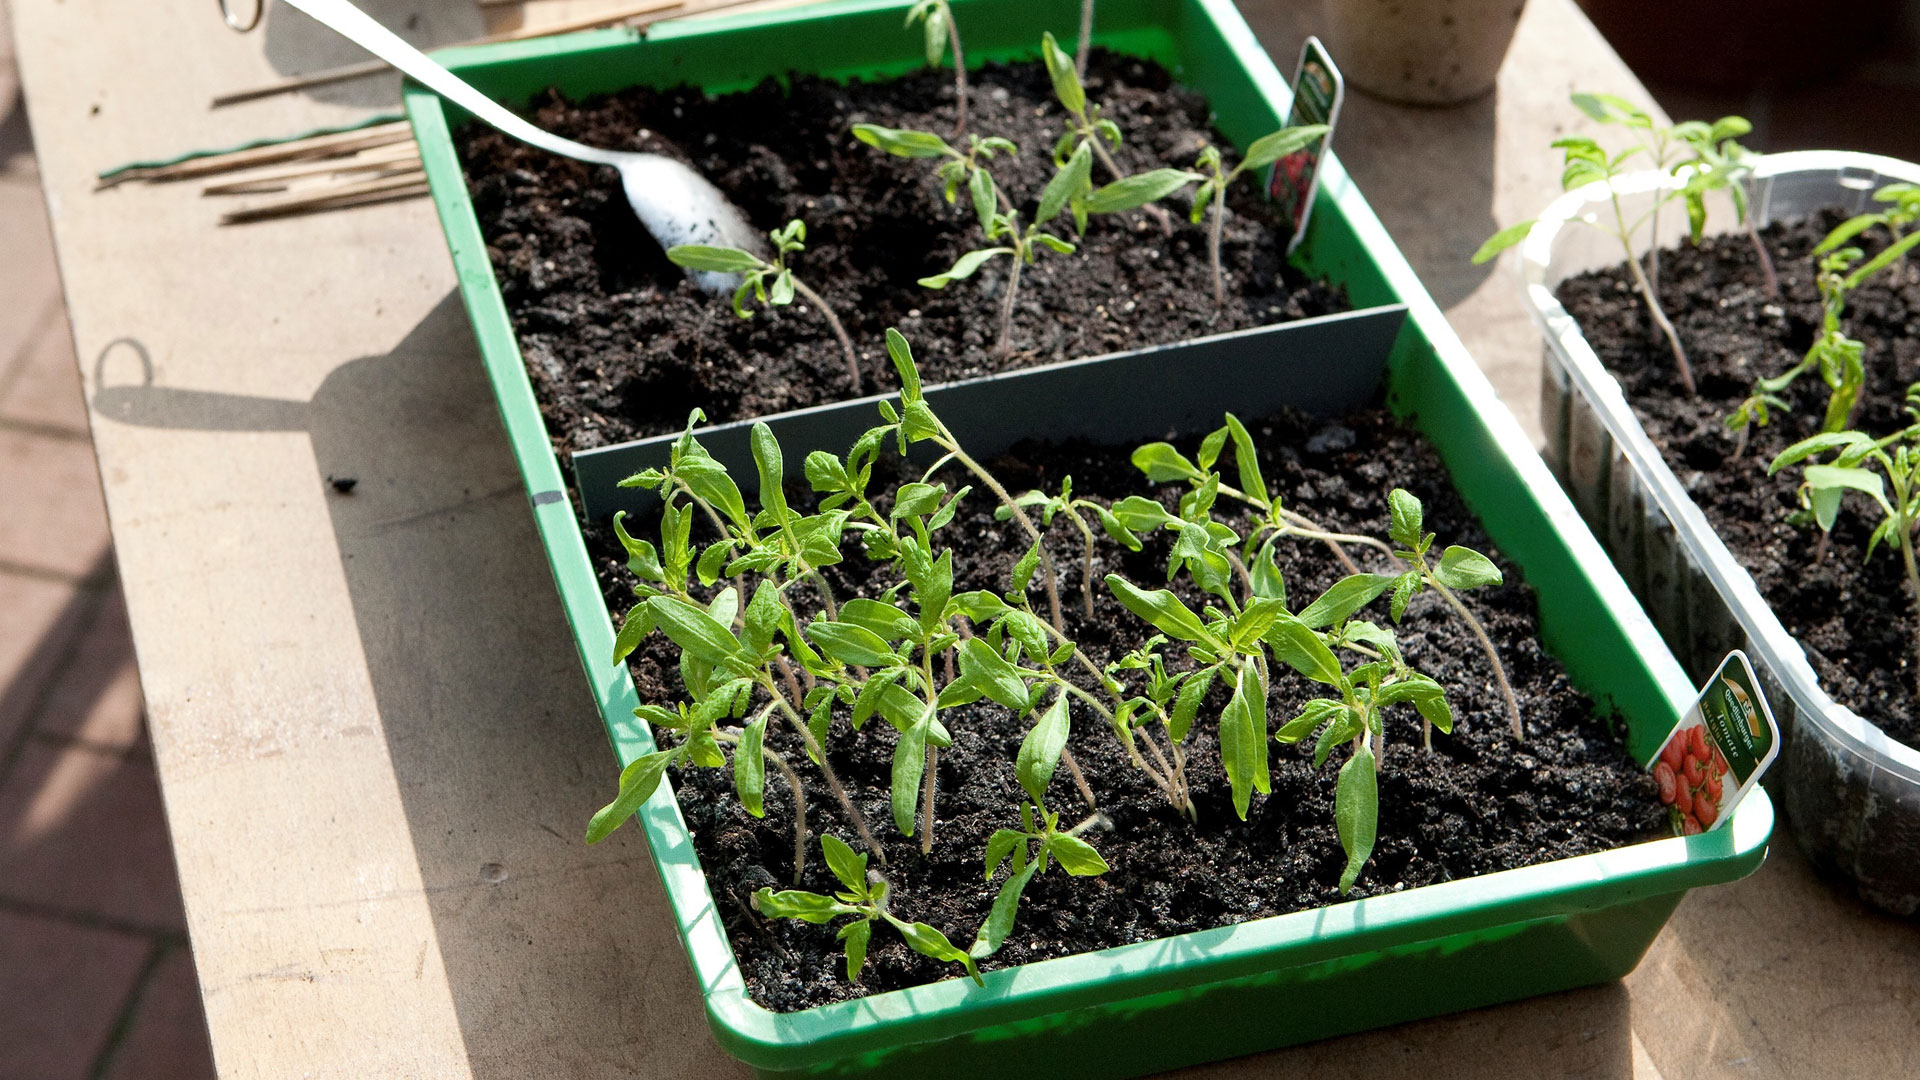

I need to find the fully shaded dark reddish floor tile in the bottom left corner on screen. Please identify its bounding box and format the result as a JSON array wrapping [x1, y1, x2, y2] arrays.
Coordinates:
[[0, 911, 154, 1080]]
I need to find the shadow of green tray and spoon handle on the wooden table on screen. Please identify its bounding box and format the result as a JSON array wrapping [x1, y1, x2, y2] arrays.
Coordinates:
[[94, 288, 1632, 1080]]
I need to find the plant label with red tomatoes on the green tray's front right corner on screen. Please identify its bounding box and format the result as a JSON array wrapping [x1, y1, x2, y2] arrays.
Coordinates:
[[1647, 650, 1780, 836]]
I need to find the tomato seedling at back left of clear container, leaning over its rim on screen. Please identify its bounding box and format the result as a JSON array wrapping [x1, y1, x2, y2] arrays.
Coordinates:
[[1473, 94, 1697, 396]]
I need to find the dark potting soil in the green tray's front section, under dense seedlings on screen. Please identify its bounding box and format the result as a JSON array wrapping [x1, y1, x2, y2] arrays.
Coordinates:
[[589, 409, 1665, 1011]]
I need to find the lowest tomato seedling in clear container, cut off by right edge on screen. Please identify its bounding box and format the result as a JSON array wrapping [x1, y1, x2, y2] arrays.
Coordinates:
[[1766, 382, 1920, 673]]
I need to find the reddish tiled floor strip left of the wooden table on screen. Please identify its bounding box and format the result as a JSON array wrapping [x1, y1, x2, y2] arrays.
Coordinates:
[[0, 4, 213, 1080]]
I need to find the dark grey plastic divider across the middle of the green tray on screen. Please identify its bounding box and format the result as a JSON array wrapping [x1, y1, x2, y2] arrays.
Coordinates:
[[574, 304, 1407, 521]]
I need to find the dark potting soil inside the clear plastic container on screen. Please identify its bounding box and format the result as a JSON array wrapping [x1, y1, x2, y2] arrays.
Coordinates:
[[1559, 211, 1920, 748]]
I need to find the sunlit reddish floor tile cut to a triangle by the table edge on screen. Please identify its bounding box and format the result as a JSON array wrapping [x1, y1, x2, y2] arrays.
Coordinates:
[[33, 588, 146, 749]]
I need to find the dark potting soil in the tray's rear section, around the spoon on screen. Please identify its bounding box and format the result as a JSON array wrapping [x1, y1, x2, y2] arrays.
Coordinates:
[[459, 50, 1348, 454]]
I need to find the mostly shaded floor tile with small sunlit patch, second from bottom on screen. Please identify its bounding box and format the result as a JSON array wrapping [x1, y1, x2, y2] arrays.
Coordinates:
[[0, 740, 184, 930]]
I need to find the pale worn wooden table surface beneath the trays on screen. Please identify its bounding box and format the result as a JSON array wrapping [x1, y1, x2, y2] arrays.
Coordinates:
[[0, 0, 1920, 1080]]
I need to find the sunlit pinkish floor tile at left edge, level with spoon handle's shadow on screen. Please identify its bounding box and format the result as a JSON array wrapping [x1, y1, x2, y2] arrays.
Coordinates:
[[0, 426, 108, 577]]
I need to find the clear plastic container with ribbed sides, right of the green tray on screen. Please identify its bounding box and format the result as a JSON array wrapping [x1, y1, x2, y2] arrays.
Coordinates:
[[1521, 150, 1920, 915]]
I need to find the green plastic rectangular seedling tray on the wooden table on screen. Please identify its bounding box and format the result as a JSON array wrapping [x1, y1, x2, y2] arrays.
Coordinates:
[[407, 0, 1772, 1076]]
